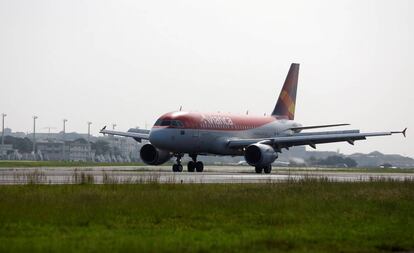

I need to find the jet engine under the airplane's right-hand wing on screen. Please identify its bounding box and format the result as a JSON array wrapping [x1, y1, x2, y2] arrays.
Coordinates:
[[244, 143, 278, 167]]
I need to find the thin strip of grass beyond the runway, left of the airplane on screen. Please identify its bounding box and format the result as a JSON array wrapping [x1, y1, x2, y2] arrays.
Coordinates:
[[0, 160, 144, 168]]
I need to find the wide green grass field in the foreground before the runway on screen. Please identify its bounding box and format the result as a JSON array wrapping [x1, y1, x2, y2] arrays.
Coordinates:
[[0, 180, 414, 252]]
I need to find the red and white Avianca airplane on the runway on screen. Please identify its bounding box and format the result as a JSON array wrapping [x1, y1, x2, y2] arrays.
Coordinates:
[[100, 63, 407, 174]]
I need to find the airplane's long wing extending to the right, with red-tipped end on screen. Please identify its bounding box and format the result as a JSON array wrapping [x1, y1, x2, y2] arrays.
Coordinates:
[[227, 129, 407, 152]]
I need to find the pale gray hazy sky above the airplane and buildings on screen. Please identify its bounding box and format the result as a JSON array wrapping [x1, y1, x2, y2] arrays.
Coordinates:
[[0, 0, 414, 156]]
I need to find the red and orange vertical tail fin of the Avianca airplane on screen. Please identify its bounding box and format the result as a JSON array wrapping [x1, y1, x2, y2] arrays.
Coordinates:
[[272, 63, 299, 120]]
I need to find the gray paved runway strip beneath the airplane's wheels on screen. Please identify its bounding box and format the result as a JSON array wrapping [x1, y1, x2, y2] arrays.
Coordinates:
[[0, 166, 414, 185]]
